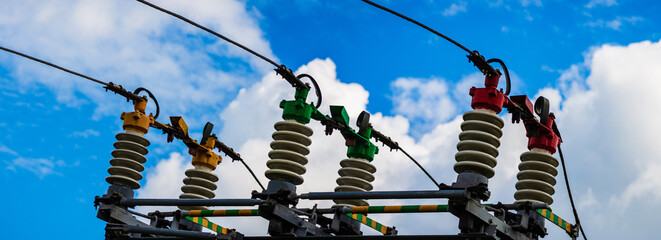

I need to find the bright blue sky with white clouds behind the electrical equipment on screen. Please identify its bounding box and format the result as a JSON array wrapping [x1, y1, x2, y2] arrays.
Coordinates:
[[0, 0, 661, 239]]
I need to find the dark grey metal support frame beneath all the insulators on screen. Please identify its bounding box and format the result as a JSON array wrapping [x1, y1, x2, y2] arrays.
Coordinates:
[[97, 187, 548, 240]]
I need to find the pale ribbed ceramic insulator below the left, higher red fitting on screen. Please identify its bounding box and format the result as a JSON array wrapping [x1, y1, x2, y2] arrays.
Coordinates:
[[454, 109, 505, 178]]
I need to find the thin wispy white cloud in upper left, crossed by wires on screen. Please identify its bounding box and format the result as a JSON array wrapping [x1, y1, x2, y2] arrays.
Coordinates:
[[0, 0, 277, 126]]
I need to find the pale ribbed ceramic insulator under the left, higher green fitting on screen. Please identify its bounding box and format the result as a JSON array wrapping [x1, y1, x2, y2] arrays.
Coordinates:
[[264, 120, 313, 185]]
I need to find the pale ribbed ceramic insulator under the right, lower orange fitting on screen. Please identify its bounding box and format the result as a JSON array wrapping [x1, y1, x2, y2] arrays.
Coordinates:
[[179, 166, 218, 210]]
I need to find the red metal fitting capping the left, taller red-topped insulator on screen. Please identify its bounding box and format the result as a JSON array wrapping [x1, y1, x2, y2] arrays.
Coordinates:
[[468, 75, 507, 114]]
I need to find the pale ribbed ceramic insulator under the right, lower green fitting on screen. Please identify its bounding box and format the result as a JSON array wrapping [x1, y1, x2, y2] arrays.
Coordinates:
[[333, 158, 376, 207]]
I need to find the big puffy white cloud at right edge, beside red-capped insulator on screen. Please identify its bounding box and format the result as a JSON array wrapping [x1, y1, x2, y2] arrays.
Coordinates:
[[540, 41, 661, 238]]
